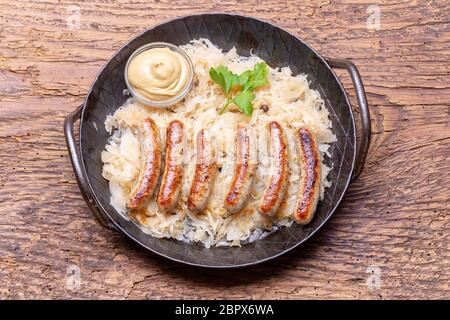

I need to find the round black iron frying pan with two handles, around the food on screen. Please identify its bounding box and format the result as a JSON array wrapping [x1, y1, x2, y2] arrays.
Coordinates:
[[64, 14, 370, 268]]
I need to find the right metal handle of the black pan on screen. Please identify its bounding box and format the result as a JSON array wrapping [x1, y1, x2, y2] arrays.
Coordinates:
[[325, 58, 371, 182]]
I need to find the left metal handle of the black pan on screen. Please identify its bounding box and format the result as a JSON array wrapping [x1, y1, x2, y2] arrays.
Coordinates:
[[64, 105, 115, 230]]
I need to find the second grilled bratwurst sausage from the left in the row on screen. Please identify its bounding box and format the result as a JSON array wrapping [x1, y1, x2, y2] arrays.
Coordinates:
[[157, 120, 184, 211]]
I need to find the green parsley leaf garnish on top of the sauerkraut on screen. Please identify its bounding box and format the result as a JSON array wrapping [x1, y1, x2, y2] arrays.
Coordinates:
[[209, 62, 269, 116]]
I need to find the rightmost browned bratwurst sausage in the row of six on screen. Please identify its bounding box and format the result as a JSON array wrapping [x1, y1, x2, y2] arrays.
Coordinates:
[[294, 128, 321, 225]]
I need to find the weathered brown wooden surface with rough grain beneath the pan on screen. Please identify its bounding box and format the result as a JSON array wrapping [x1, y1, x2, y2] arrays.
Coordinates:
[[0, 0, 450, 299]]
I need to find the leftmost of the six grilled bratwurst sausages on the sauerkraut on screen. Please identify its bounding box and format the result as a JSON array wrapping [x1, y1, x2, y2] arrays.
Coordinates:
[[127, 118, 161, 209]]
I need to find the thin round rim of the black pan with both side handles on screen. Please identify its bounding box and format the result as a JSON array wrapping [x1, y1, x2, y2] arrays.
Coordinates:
[[64, 12, 371, 269]]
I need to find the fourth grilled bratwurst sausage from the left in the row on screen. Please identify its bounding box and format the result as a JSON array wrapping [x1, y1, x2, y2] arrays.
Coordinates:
[[225, 125, 256, 213]]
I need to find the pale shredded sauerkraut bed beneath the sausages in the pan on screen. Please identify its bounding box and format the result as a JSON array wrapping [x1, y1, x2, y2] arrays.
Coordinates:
[[102, 39, 336, 247]]
